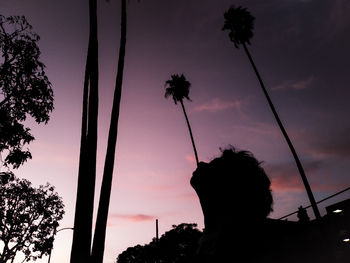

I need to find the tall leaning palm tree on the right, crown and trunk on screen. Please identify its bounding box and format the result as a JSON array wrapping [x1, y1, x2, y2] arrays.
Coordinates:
[[222, 6, 321, 219]]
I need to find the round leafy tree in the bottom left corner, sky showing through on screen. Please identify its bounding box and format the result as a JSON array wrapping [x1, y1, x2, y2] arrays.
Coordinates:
[[0, 174, 64, 263]]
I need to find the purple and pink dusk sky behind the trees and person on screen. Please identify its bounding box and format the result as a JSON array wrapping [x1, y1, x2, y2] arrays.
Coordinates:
[[0, 0, 350, 263]]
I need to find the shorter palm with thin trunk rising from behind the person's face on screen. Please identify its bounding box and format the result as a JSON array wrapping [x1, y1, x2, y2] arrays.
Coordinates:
[[165, 74, 199, 166]]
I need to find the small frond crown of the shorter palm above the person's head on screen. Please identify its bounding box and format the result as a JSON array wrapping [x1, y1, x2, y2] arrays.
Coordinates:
[[165, 74, 191, 104]]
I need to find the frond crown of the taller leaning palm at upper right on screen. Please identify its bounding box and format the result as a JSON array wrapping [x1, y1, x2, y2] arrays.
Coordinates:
[[222, 6, 255, 48]]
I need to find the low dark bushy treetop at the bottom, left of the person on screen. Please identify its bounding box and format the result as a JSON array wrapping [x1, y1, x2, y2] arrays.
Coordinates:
[[117, 223, 202, 263]]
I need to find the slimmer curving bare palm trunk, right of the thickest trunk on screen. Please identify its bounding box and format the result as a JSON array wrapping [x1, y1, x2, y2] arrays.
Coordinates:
[[92, 0, 126, 263]]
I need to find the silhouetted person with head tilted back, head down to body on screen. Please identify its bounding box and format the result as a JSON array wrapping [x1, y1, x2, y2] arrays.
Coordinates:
[[190, 146, 273, 263]]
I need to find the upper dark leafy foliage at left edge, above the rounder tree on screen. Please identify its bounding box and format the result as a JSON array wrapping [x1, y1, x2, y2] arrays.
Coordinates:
[[0, 15, 53, 171]]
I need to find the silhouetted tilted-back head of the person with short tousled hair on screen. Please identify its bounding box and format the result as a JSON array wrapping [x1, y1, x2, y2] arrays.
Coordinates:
[[191, 147, 272, 220]]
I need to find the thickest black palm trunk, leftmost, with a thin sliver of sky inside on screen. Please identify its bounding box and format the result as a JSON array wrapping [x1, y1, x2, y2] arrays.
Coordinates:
[[71, 0, 98, 263]]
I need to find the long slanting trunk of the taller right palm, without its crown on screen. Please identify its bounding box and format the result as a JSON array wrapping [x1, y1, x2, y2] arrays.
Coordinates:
[[242, 42, 321, 219]]
